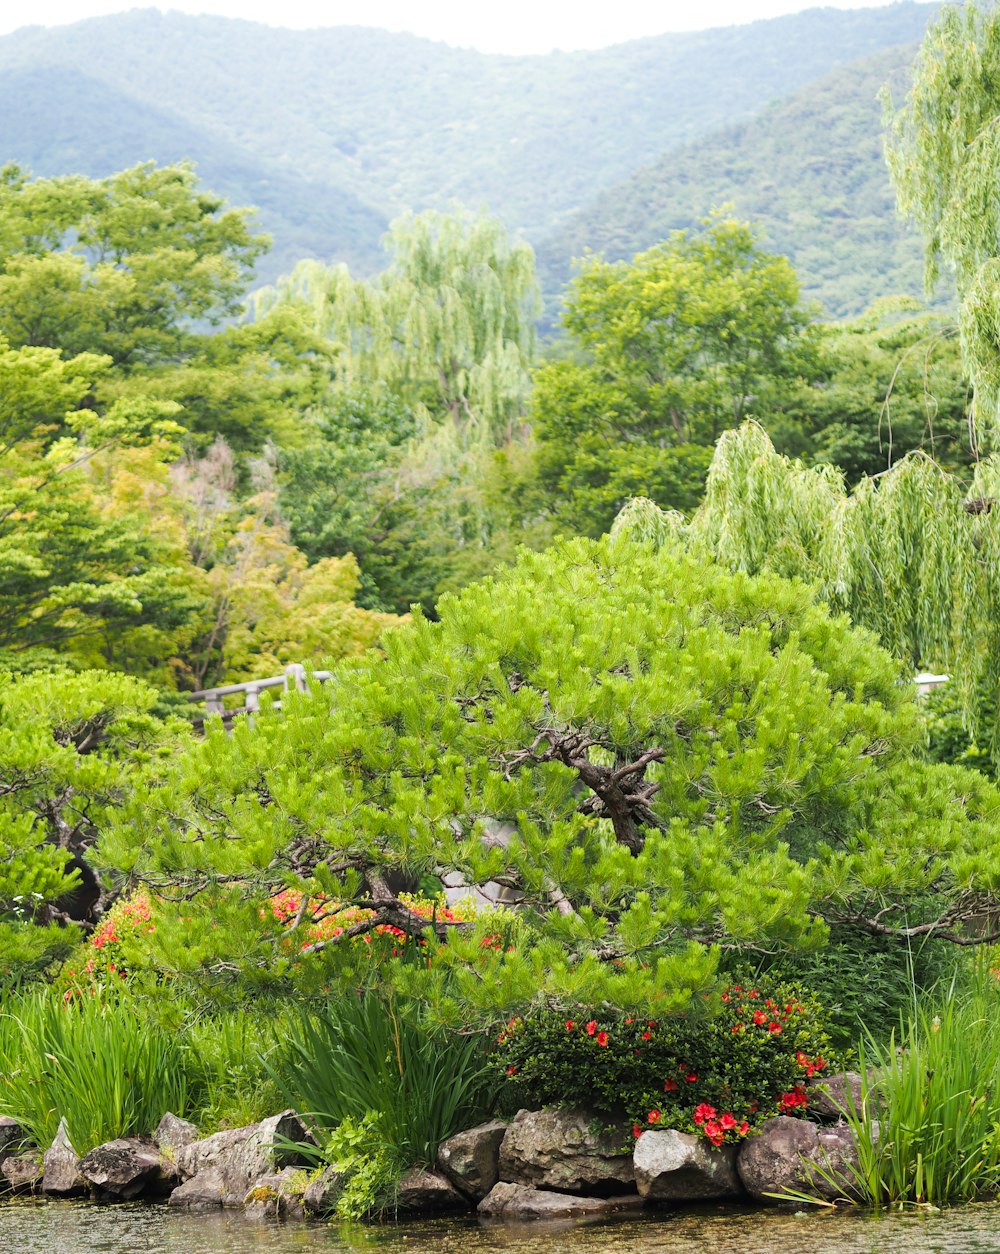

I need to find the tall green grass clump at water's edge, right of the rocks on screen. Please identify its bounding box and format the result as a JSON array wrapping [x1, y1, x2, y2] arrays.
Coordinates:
[[833, 973, 1000, 1205]]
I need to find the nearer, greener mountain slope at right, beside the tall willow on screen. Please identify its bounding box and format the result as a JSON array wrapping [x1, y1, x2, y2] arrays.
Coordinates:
[[538, 46, 938, 317]]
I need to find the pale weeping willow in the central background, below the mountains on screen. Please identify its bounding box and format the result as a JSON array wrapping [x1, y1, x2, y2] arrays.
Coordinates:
[[253, 211, 541, 441]]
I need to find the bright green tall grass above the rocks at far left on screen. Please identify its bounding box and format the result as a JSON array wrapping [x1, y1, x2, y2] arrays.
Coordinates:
[[0, 989, 203, 1154]]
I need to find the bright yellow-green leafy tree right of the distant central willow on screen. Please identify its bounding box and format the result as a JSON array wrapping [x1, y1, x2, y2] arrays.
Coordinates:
[[531, 214, 808, 535]]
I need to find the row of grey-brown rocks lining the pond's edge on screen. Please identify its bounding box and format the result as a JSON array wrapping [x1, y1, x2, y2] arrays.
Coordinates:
[[0, 1073, 861, 1220]]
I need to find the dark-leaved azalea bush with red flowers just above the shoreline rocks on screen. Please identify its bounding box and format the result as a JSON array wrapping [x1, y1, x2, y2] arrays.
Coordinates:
[[493, 984, 833, 1146]]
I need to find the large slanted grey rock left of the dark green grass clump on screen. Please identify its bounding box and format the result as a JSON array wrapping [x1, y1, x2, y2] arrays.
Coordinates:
[[177, 1110, 315, 1206]]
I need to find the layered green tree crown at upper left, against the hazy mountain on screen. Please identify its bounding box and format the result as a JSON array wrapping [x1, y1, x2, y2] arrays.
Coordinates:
[[0, 162, 266, 371]]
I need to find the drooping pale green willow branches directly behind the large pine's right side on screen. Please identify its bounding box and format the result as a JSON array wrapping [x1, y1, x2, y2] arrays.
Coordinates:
[[612, 421, 1000, 761]]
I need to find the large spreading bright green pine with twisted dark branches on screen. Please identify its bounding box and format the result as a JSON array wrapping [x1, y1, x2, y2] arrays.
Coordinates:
[[100, 540, 1000, 1021]]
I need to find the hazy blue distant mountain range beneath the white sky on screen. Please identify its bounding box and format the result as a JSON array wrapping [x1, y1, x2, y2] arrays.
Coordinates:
[[0, 0, 936, 283]]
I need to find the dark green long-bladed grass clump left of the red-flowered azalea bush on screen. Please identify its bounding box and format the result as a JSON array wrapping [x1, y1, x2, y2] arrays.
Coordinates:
[[267, 994, 497, 1166]]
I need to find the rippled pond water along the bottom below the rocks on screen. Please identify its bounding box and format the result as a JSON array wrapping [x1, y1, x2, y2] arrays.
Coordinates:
[[0, 1201, 1000, 1254]]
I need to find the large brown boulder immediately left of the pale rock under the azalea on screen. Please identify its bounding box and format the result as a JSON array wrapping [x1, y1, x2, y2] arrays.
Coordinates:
[[499, 1110, 635, 1196]]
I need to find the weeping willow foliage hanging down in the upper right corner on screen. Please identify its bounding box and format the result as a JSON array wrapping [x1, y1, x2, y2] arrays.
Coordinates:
[[885, 0, 1000, 434]]
